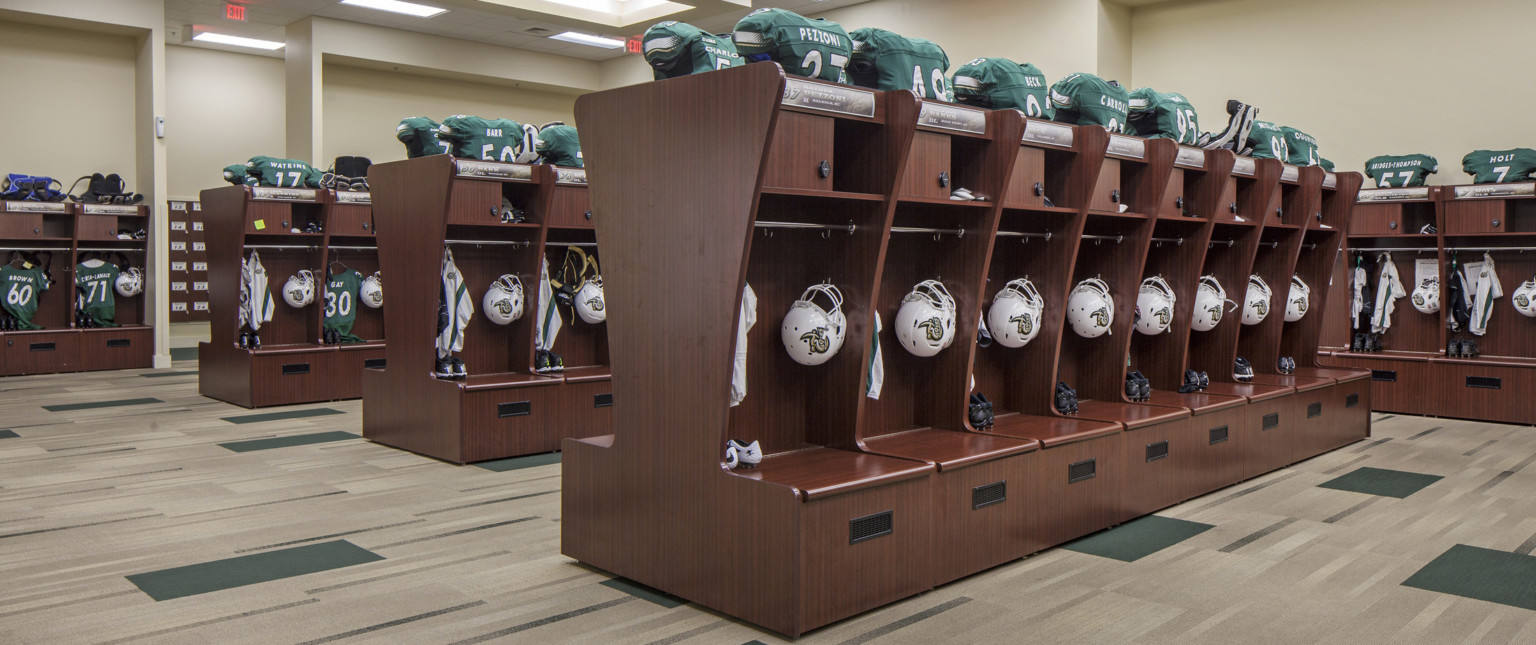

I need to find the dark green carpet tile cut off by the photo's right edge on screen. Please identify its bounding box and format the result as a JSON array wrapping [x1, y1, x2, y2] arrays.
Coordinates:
[[1402, 544, 1536, 610]]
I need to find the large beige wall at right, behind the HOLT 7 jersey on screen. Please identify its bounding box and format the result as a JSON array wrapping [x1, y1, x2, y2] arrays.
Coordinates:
[[1132, 0, 1536, 184]]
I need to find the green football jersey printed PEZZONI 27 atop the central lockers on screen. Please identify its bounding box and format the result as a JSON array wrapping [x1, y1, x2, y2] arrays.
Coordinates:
[[731, 9, 854, 83]]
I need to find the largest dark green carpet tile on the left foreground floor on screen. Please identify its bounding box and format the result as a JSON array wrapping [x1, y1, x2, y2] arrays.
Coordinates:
[[127, 539, 384, 600]]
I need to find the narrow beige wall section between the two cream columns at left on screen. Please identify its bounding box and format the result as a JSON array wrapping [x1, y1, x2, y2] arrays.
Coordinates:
[[166, 48, 284, 198]]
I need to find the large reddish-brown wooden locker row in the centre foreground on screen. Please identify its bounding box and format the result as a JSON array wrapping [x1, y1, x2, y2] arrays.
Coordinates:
[[562, 65, 1369, 636]]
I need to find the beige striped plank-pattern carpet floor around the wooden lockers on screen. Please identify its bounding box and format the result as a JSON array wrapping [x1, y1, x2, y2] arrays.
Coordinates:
[[0, 361, 1536, 645]]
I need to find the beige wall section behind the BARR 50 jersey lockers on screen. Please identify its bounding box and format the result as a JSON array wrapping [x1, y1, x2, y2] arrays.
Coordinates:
[[324, 65, 576, 167]]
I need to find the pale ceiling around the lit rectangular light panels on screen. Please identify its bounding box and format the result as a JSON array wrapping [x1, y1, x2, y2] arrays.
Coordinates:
[[166, 0, 868, 60]]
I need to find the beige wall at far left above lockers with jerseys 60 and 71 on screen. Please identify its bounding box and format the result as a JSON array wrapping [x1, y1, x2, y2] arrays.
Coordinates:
[[0, 22, 144, 190]]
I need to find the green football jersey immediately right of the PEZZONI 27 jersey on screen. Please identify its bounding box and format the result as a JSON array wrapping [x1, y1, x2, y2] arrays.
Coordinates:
[[846, 28, 954, 101]]
